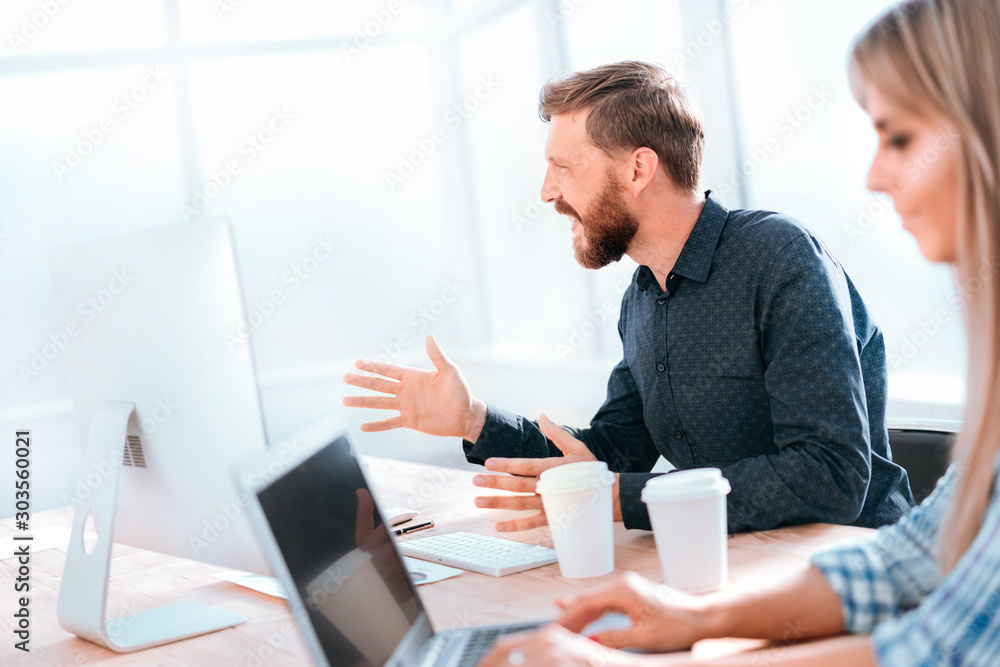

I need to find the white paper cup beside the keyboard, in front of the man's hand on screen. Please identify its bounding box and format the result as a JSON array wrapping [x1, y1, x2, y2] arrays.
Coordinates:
[[535, 461, 615, 579]]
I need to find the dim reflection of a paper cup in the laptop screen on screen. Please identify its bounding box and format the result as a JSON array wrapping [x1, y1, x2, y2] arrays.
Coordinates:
[[305, 549, 410, 665]]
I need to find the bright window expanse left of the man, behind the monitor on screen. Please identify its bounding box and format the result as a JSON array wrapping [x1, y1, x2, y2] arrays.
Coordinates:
[[0, 0, 696, 407]]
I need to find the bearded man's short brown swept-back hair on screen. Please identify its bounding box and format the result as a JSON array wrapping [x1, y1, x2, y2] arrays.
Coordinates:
[[538, 60, 705, 192]]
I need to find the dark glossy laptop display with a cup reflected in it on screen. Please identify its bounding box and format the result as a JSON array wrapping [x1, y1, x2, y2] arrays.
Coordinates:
[[257, 437, 423, 667]]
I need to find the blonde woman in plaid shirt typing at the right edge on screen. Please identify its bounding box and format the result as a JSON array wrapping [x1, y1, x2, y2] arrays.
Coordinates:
[[483, 0, 1000, 667]]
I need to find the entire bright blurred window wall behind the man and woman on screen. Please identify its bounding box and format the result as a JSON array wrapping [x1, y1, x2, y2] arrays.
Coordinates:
[[0, 0, 965, 516]]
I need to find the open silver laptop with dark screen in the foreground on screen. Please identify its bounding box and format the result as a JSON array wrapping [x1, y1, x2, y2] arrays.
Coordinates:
[[235, 421, 542, 667]]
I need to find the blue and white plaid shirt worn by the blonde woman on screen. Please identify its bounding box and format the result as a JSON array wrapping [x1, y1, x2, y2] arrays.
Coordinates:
[[812, 466, 1000, 667]]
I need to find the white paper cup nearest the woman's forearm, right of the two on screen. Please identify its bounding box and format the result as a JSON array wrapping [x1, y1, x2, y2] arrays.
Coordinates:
[[642, 468, 731, 593]]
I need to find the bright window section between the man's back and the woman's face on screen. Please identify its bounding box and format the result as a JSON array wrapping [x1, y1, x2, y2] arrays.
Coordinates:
[[727, 0, 966, 410]]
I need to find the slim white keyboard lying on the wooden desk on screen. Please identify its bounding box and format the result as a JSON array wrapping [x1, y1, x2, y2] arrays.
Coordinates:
[[399, 532, 557, 577]]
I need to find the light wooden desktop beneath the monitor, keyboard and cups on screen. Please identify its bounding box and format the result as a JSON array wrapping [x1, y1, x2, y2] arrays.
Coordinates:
[[0, 458, 873, 667]]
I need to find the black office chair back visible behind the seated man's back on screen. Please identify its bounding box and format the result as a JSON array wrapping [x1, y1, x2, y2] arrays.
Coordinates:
[[888, 419, 962, 504]]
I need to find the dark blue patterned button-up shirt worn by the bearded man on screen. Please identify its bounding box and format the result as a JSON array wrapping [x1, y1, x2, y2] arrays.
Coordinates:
[[464, 193, 913, 532]]
